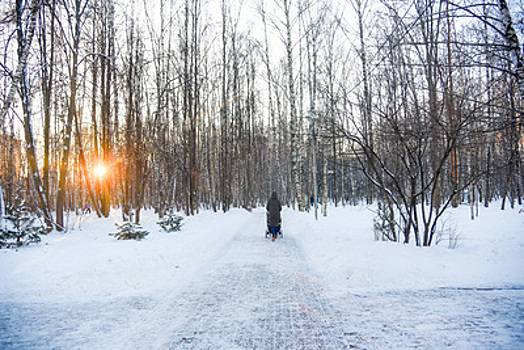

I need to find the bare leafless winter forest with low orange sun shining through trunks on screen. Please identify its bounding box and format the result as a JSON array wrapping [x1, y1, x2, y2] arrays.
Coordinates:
[[0, 0, 524, 246]]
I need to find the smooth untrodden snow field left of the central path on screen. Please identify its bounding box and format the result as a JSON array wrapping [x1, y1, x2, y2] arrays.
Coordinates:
[[0, 209, 254, 302]]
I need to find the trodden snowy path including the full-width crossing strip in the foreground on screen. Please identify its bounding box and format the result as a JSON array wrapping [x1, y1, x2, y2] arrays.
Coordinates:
[[0, 212, 524, 350]]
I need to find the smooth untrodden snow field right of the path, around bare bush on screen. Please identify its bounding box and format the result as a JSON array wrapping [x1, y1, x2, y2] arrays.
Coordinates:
[[294, 203, 524, 293]]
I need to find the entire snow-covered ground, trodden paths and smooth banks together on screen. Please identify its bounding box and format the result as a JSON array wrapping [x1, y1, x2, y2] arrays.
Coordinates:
[[0, 202, 524, 349]]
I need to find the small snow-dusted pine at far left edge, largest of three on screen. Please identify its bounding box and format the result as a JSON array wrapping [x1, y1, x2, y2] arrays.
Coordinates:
[[0, 193, 47, 248]]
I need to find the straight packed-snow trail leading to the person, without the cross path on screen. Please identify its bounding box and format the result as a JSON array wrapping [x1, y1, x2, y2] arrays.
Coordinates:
[[107, 213, 349, 349]]
